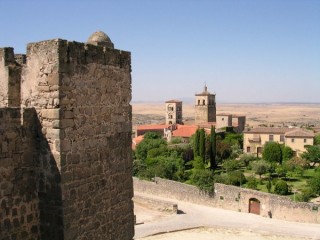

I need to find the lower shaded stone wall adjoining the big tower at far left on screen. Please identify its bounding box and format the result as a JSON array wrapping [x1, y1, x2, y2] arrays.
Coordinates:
[[0, 108, 40, 239]]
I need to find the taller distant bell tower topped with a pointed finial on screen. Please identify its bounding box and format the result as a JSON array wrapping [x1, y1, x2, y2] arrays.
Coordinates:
[[195, 85, 216, 125]]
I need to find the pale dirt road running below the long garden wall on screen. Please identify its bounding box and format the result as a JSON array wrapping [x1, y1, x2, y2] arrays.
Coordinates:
[[135, 193, 320, 240]]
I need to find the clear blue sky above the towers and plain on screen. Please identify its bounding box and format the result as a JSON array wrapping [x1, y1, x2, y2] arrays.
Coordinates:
[[0, 0, 320, 103]]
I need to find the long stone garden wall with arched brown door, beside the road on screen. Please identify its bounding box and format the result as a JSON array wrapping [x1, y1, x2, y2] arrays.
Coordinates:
[[133, 178, 320, 223]]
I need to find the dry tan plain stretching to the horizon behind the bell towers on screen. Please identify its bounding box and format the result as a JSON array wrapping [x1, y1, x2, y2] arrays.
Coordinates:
[[132, 103, 320, 126]]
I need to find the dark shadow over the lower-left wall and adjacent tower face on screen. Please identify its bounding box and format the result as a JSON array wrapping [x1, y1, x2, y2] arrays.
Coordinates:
[[0, 108, 63, 239]]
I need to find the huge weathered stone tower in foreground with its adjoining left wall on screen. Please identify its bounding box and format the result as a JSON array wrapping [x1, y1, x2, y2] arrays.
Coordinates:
[[0, 32, 134, 240]]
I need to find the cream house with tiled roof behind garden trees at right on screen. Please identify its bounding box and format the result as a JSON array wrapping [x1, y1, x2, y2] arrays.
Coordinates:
[[243, 127, 314, 156]]
